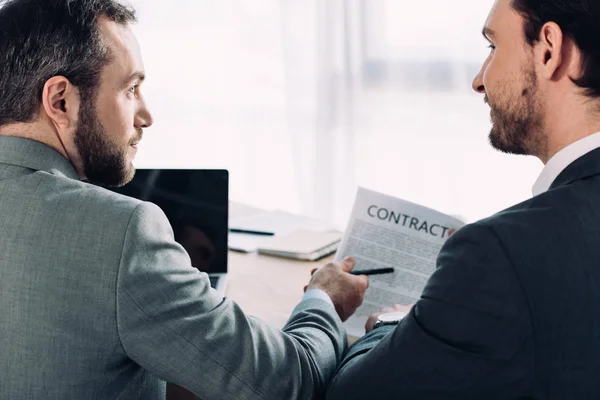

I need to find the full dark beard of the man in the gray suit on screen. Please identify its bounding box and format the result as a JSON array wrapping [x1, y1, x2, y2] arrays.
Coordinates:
[[75, 96, 142, 187]]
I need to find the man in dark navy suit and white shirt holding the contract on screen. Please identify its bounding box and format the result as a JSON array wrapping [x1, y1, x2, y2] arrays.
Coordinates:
[[328, 0, 600, 400]]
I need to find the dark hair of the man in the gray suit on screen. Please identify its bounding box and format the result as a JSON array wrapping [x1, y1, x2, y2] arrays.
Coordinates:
[[0, 0, 136, 126]]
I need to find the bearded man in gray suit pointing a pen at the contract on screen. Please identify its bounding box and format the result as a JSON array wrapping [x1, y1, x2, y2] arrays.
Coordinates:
[[0, 0, 368, 400]]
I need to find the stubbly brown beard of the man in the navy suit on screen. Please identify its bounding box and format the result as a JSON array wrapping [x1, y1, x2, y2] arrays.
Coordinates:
[[485, 68, 547, 156]]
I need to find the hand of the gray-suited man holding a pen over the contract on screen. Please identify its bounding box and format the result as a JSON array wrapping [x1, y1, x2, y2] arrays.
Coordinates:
[[304, 257, 369, 321]]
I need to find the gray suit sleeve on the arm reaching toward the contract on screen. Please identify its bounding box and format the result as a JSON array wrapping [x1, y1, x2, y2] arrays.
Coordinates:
[[117, 203, 346, 400]]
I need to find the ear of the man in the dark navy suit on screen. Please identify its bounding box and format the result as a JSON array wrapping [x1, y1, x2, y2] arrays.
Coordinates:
[[535, 22, 565, 80]]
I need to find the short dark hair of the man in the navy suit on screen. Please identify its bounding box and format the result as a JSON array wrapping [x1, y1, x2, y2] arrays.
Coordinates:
[[512, 0, 600, 98]]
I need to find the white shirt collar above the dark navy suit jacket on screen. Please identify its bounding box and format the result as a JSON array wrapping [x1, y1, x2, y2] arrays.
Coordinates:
[[532, 132, 600, 196]]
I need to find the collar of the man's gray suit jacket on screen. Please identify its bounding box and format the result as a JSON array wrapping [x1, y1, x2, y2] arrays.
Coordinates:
[[0, 136, 79, 180]]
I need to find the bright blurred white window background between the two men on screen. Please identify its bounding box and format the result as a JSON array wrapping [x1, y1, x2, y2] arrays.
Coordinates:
[[130, 0, 542, 228]]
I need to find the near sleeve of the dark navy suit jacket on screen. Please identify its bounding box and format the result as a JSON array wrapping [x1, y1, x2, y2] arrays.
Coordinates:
[[327, 225, 534, 400]]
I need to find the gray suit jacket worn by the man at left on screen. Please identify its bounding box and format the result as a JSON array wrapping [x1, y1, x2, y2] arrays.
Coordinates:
[[0, 136, 346, 400]]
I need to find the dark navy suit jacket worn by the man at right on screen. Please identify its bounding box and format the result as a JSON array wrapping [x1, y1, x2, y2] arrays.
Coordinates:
[[328, 149, 600, 400]]
